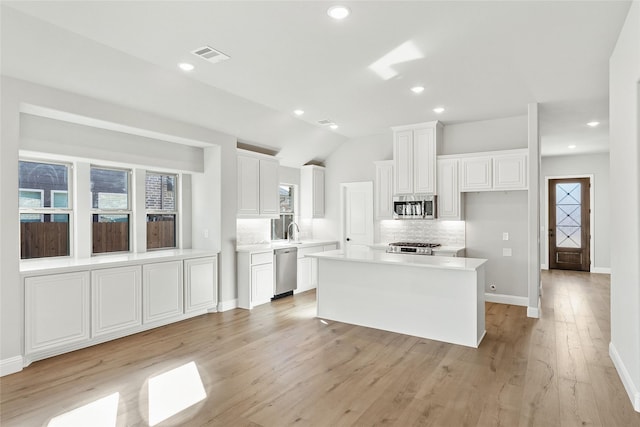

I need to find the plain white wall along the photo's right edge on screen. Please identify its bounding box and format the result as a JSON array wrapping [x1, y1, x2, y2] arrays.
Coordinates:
[[609, 0, 640, 412]]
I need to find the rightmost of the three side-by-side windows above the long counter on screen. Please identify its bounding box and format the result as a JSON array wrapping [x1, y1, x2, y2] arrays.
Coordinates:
[[144, 172, 178, 249]]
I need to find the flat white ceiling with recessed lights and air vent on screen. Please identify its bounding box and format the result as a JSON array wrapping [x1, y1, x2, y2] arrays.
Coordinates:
[[3, 0, 630, 161]]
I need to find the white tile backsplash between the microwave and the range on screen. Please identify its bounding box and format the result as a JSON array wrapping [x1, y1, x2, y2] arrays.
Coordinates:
[[378, 220, 465, 246]]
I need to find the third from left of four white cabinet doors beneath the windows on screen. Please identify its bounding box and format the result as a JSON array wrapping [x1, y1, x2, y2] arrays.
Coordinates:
[[142, 261, 183, 323]]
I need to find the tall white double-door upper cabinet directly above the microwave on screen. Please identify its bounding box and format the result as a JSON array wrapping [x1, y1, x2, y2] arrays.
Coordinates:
[[392, 121, 442, 194]]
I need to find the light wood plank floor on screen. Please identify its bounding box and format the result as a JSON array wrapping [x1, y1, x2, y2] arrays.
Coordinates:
[[0, 271, 640, 427]]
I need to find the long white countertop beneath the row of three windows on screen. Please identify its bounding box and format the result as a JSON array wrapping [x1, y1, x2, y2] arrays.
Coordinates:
[[20, 249, 218, 275]]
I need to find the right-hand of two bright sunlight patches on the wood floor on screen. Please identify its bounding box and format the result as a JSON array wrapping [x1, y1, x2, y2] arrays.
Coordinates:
[[149, 362, 207, 426]]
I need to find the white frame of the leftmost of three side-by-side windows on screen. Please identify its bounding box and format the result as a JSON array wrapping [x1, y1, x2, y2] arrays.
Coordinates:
[[18, 156, 75, 262]]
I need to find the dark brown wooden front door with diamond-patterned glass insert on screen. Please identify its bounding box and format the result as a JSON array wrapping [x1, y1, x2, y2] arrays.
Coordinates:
[[549, 178, 591, 271]]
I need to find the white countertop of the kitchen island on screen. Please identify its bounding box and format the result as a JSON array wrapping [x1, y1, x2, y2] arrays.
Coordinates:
[[306, 248, 487, 271]]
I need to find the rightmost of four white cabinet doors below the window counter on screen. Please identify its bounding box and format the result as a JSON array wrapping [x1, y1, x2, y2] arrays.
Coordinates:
[[184, 257, 218, 313]]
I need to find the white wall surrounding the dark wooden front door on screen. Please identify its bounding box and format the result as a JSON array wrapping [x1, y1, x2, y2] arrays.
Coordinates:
[[540, 153, 611, 272]]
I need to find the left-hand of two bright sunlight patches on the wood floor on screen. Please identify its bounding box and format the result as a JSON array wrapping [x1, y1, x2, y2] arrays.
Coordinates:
[[47, 393, 120, 427]]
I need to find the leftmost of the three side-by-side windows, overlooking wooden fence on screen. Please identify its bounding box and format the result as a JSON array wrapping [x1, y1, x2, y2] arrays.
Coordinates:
[[18, 160, 71, 259]]
